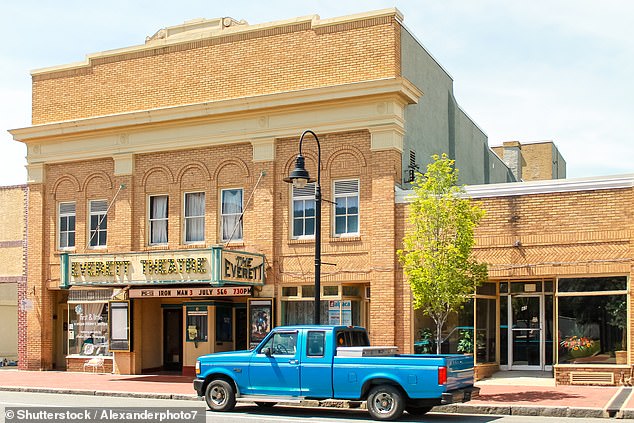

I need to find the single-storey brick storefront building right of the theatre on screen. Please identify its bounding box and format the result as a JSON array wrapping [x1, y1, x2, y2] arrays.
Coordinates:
[[396, 175, 634, 384]]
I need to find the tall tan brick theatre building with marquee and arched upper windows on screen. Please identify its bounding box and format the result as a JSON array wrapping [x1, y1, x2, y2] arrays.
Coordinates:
[[11, 9, 620, 386]]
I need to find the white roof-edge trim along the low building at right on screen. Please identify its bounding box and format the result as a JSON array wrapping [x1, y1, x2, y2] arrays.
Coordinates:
[[395, 174, 634, 204]]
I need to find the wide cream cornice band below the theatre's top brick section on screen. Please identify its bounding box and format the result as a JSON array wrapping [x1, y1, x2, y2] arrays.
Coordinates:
[[9, 78, 422, 167]]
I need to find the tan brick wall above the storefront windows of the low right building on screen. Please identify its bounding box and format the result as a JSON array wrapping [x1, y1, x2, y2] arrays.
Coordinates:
[[397, 188, 634, 372]]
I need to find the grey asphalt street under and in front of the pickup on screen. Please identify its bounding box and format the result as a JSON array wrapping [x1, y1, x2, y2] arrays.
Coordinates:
[[0, 391, 606, 423]]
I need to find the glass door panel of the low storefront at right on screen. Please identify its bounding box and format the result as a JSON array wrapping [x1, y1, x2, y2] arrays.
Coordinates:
[[508, 295, 544, 370]]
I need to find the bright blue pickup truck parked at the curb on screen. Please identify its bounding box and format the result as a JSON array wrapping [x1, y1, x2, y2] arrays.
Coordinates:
[[194, 325, 478, 420]]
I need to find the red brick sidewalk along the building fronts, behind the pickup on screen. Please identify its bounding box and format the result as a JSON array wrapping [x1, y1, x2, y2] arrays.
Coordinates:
[[0, 368, 634, 418]]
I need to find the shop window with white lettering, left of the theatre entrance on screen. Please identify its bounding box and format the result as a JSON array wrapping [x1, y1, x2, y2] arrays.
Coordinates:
[[68, 302, 112, 356]]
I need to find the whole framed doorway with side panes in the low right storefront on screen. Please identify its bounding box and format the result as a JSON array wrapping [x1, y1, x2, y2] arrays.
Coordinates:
[[501, 294, 552, 371]]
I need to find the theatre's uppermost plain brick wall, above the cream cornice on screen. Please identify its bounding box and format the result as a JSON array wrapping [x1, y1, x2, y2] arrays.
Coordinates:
[[32, 17, 400, 124]]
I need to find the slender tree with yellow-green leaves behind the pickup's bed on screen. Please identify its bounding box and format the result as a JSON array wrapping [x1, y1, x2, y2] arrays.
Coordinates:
[[397, 154, 487, 354]]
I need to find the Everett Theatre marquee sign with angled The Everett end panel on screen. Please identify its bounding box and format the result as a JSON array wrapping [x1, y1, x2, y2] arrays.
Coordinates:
[[60, 246, 264, 287]]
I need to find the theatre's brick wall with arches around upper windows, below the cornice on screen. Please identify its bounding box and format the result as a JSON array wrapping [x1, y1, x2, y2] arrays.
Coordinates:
[[29, 131, 400, 368]]
